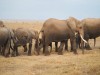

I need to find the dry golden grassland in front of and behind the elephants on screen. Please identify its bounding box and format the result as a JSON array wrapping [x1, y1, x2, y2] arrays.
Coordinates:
[[0, 21, 100, 75]]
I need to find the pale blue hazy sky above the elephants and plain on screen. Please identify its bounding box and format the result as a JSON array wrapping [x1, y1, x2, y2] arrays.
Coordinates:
[[0, 0, 100, 20]]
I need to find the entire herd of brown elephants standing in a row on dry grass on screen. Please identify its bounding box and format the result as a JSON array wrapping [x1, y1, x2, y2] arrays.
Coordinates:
[[0, 17, 100, 57]]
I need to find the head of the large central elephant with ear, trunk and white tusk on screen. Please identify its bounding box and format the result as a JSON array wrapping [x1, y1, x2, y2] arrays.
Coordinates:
[[67, 17, 88, 53]]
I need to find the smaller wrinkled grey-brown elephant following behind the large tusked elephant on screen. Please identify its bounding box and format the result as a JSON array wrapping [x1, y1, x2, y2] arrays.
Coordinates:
[[12, 28, 38, 56]]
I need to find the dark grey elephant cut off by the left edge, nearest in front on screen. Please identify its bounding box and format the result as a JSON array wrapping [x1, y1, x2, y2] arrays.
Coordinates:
[[0, 26, 11, 57]]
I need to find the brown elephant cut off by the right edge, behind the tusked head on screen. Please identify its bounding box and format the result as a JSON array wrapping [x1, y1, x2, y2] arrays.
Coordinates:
[[79, 18, 100, 49]]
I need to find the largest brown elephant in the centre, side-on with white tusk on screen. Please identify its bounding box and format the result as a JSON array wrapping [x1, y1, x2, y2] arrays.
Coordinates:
[[37, 17, 86, 55]]
